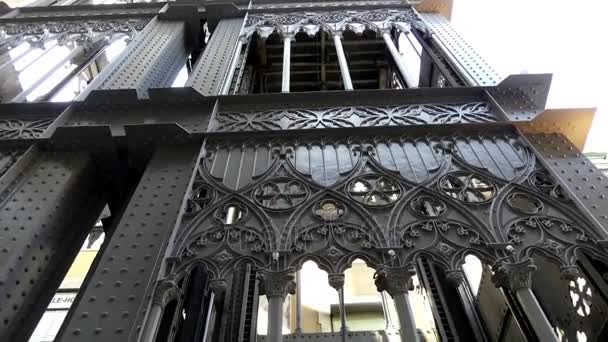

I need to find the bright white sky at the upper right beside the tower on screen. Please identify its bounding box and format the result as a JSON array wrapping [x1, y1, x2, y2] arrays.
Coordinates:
[[452, 0, 608, 152]]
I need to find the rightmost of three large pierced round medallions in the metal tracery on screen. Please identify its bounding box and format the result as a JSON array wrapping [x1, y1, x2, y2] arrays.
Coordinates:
[[439, 172, 496, 203]]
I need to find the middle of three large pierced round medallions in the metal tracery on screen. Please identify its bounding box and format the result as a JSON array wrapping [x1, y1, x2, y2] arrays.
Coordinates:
[[348, 175, 402, 207]]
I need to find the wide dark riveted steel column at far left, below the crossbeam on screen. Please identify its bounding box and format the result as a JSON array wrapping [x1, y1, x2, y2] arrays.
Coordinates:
[[0, 148, 105, 341]]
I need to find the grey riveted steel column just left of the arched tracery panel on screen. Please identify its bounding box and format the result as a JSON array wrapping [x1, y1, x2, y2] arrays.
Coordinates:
[[56, 144, 200, 342]]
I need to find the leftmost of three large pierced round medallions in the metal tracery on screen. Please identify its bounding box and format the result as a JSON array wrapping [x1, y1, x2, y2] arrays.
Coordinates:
[[253, 177, 309, 210]]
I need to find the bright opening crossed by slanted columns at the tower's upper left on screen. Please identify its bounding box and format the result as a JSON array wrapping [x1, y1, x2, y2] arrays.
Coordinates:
[[0, 28, 130, 102]]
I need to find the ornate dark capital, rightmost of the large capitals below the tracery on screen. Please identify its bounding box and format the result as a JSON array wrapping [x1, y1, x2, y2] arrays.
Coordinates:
[[492, 258, 537, 292]]
